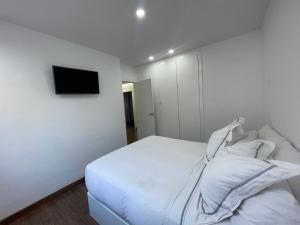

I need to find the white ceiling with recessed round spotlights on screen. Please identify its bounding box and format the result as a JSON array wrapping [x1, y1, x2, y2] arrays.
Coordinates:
[[0, 0, 269, 65]]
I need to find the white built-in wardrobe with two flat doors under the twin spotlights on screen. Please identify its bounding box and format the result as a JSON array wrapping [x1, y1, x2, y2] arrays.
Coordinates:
[[139, 52, 203, 141]]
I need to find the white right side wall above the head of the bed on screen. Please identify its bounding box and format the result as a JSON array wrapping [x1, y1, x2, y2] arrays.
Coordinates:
[[263, 0, 300, 151]]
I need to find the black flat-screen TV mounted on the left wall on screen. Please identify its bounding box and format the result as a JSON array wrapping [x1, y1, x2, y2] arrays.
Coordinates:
[[52, 66, 99, 94]]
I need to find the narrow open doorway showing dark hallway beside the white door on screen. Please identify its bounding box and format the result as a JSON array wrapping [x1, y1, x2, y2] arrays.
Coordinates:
[[122, 82, 137, 144]]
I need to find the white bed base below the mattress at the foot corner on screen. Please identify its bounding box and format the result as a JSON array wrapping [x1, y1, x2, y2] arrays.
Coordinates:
[[87, 193, 129, 225]]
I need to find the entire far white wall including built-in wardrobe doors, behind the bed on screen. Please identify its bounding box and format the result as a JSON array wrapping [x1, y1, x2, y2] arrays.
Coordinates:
[[136, 30, 264, 141]]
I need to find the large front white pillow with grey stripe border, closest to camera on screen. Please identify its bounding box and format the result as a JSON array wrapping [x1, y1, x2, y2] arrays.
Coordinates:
[[199, 154, 300, 224]]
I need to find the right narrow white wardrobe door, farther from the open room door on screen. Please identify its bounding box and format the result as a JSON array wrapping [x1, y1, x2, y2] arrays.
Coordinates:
[[176, 53, 201, 141]]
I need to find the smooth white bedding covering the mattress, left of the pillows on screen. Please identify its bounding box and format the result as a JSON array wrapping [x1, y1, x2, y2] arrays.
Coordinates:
[[85, 136, 230, 225]]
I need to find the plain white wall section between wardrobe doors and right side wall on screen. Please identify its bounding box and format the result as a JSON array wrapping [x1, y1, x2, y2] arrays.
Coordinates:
[[202, 31, 264, 140]]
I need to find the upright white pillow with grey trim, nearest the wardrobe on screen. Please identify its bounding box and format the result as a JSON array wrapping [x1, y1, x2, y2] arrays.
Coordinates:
[[206, 117, 245, 161]]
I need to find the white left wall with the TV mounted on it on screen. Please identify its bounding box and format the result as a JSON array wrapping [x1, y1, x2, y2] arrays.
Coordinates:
[[0, 22, 126, 220]]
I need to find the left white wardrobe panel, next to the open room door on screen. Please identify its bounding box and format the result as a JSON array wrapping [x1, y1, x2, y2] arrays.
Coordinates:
[[152, 58, 179, 138]]
